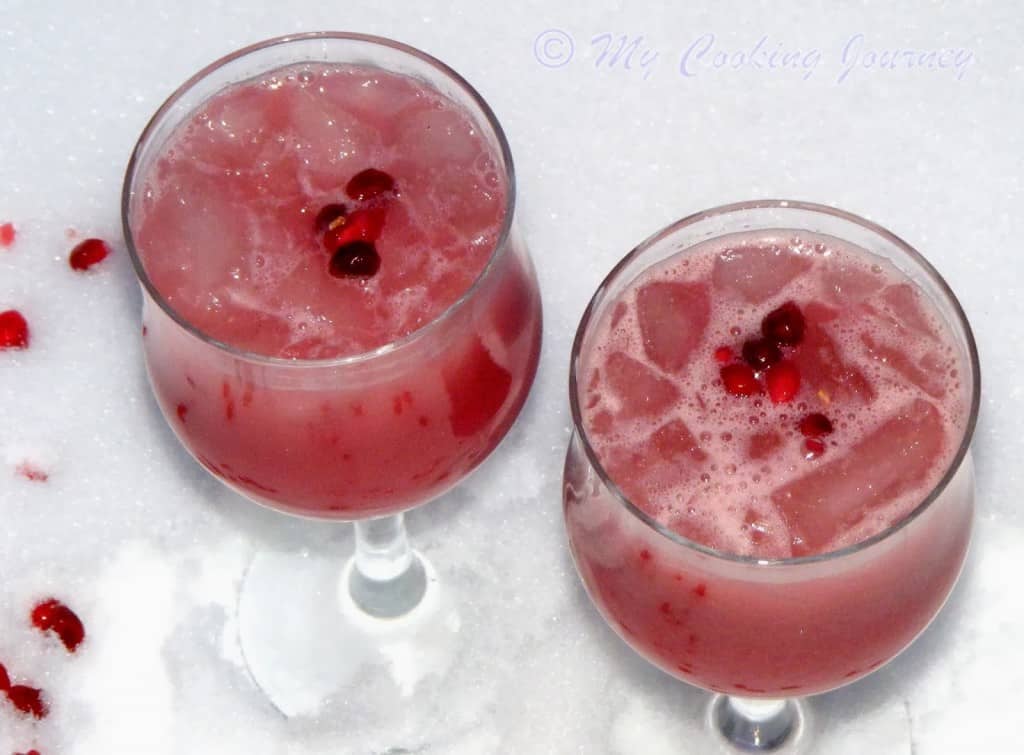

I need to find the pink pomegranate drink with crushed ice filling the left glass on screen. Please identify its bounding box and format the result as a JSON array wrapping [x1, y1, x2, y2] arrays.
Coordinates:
[[131, 64, 541, 518]]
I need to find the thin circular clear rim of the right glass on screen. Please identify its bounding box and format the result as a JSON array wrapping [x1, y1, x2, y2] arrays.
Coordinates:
[[569, 199, 981, 568]]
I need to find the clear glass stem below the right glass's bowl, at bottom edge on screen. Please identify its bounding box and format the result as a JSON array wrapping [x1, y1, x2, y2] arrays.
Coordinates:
[[712, 695, 801, 752]]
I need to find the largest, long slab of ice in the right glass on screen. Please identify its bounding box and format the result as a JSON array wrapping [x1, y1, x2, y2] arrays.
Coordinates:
[[771, 399, 945, 556]]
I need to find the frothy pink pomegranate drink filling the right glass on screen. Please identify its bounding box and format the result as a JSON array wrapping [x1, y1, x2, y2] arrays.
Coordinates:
[[565, 230, 973, 698]]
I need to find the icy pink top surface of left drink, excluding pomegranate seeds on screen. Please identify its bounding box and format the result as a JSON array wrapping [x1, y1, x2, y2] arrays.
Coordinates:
[[134, 64, 507, 359]]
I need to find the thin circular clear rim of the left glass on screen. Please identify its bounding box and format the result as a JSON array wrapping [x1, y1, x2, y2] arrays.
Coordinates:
[[121, 32, 516, 368]]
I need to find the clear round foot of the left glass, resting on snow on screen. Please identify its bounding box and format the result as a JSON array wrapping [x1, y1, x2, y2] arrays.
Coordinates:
[[239, 551, 460, 717]]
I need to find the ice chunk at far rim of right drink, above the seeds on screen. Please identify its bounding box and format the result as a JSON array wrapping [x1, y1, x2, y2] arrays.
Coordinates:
[[712, 239, 812, 304]]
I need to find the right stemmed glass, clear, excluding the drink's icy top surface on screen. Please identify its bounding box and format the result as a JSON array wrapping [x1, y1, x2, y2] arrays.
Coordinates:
[[564, 201, 980, 750]]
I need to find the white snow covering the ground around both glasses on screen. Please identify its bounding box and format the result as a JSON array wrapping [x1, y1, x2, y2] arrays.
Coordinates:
[[0, 0, 1024, 755]]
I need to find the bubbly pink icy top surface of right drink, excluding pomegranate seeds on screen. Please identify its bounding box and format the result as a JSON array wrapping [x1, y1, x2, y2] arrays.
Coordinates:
[[581, 230, 968, 557]]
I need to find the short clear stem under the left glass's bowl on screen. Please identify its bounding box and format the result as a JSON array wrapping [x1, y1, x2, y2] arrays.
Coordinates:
[[348, 514, 427, 619]]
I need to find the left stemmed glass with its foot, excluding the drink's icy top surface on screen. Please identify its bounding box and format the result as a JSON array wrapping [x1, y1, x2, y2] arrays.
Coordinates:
[[122, 33, 541, 715]]
